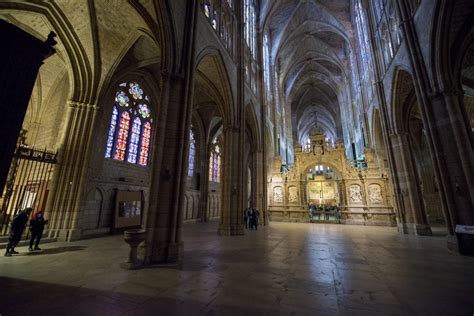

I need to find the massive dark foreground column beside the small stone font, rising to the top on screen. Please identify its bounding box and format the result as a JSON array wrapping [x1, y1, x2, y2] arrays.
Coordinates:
[[144, 1, 199, 264]]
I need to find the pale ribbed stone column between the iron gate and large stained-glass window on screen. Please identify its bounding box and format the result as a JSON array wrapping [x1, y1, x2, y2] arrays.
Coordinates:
[[45, 101, 98, 241]]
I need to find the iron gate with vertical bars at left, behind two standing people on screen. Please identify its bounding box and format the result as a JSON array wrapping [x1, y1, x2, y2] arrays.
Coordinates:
[[0, 145, 56, 235]]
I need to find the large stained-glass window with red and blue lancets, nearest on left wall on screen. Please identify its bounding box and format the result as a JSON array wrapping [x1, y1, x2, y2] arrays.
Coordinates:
[[105, 82, 153, 166]]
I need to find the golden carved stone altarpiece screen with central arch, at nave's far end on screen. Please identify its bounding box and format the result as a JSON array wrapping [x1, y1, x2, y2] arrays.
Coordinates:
[[268, 134, 396, 226]]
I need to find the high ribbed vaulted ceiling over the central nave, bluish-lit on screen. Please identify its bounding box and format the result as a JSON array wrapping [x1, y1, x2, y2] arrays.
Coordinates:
[[260, 0, 352, 142]]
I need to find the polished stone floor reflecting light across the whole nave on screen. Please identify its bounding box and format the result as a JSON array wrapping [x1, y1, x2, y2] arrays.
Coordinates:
[[0, 223, 474, 316]]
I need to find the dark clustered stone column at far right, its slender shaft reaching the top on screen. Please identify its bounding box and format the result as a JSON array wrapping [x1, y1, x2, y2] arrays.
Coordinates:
[[397, 0, 474, 254]]
